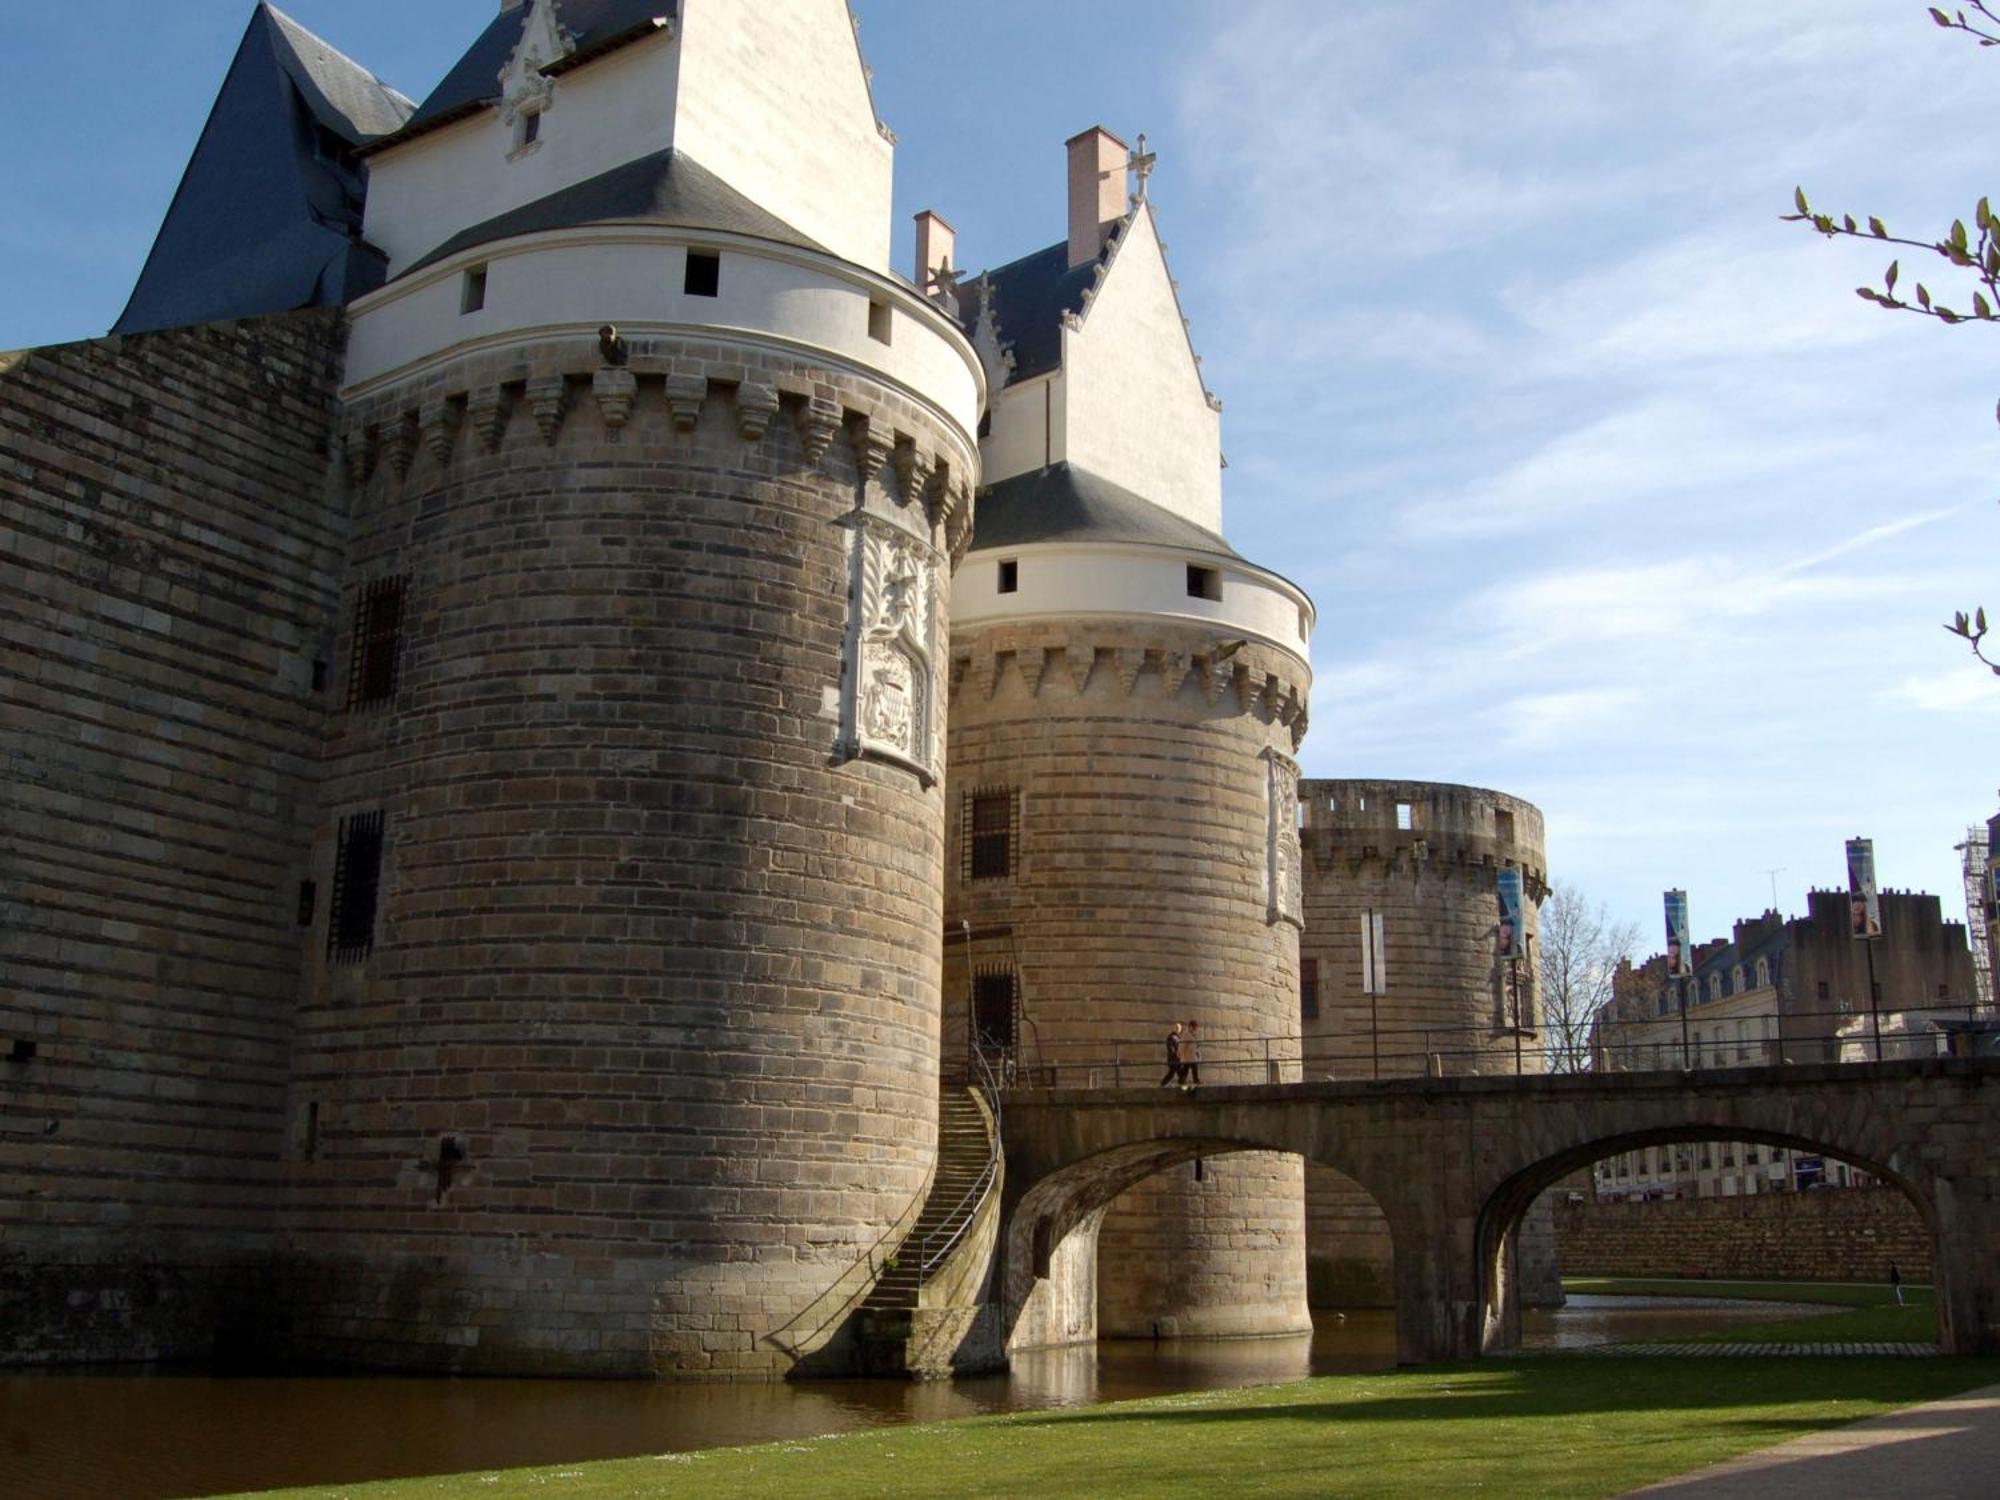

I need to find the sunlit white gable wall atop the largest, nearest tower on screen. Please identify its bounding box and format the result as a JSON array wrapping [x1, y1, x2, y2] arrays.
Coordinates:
[[672, 0, 896, 274]]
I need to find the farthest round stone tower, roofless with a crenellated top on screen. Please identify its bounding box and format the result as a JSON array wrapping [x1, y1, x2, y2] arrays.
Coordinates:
[[1298, 780, 1560, 1306]]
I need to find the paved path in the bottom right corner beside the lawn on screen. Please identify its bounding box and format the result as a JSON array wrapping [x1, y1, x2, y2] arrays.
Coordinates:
[[1632, 1384, 2000, 1500]]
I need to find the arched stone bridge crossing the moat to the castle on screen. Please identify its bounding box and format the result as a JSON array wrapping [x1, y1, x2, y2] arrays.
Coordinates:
[[996, 1058, 2000, 1364]]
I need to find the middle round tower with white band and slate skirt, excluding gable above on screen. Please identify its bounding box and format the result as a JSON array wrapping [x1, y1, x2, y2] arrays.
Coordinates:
[[944, 470, 1310, 1338]]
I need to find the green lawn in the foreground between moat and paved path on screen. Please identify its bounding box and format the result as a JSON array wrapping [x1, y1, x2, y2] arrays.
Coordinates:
[[227, 1356, 2000, 1500]]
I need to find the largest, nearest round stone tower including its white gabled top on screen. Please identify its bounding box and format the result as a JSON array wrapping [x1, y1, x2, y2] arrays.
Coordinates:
[[286, 0, 984, 1378]]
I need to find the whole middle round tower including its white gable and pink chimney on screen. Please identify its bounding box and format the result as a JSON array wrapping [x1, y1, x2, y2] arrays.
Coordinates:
[[944, 128, 1312, 1346]]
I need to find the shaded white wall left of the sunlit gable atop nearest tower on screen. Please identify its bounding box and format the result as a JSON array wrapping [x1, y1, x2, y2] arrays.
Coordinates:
[[366, 31, 688, 276]]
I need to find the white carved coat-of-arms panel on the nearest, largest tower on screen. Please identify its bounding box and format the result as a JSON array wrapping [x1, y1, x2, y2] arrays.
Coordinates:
[[842, 510, 946, 786]]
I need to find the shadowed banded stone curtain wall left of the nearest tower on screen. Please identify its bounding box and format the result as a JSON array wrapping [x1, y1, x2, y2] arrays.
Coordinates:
[[0, 314, 344, 1360]]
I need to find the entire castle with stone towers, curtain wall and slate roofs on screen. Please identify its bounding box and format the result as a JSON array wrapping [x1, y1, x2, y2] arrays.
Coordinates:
[[0, 0, 1544, 1378]]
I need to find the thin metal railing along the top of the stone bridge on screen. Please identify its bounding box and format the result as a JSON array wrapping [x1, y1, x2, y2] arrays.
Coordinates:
[[964, 1002, 2000, 1090]]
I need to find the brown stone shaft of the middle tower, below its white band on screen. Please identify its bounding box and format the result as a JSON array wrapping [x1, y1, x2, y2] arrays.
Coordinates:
[[944, 620, 1308, 1338]]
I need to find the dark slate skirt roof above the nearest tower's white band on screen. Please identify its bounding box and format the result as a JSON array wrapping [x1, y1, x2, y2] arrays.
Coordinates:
[[404, 150, 824, 274]]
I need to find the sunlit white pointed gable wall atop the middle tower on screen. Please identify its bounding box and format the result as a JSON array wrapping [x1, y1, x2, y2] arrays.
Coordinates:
[[1056, 212, 1222, 532]]
